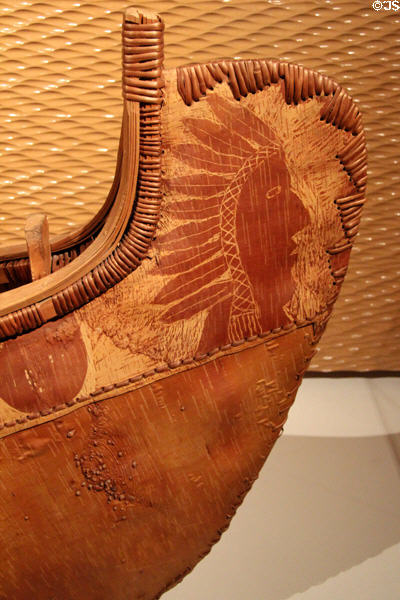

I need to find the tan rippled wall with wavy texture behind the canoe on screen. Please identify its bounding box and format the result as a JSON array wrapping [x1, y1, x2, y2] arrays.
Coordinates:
[[0, 0, 400, 370]]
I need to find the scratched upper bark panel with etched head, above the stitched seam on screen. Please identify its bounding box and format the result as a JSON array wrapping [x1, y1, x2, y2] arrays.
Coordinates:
[[0, 63, 365, 435]]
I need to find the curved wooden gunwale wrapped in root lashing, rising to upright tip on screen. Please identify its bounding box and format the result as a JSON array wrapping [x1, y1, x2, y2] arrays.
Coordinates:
[[0, 11, 163, 330]]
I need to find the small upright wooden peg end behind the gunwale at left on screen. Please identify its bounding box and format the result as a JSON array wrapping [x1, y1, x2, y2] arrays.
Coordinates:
[[25, 214, 51, 281]]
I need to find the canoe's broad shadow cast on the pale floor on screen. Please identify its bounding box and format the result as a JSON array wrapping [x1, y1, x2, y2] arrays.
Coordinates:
[[163, 434, 400, 600]]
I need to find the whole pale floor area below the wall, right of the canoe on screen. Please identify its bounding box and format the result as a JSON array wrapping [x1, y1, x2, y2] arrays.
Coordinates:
[[163, 377, 400, 600]]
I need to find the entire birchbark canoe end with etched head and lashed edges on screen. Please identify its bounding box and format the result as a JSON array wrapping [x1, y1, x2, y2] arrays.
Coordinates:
[[0, 9, 366, 600]]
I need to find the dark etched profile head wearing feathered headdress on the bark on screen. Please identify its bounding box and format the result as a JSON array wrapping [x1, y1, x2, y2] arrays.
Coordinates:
[[156, 95, 307, 340]]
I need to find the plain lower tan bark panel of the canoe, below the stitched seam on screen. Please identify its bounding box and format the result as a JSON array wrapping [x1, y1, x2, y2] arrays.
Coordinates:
[[0, 328, 313, 600]]
